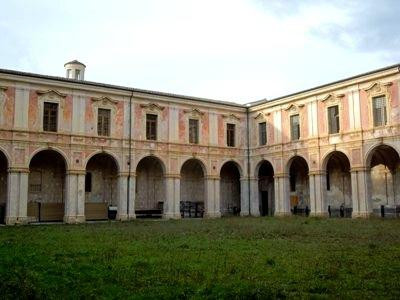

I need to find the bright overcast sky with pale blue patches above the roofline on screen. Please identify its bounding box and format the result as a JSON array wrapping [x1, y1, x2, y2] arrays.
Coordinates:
[[0, 0, 400, 103]]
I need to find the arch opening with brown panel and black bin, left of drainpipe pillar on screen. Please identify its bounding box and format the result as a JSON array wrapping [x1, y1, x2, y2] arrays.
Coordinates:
[[85, 151, 122, 220]]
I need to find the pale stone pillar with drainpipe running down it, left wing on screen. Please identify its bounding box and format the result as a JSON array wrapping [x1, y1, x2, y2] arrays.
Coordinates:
[[116, 172, 136, 221]]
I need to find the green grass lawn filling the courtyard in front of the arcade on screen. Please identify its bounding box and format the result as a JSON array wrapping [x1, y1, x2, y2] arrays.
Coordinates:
[[0, 217, 400, 299]]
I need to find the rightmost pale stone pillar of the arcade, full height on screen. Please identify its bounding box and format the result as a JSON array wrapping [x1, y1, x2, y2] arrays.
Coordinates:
[[350, 168, 372, 218]]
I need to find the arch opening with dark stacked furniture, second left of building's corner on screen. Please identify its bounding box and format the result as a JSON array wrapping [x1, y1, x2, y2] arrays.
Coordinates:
[[180, 158, 207, 218]]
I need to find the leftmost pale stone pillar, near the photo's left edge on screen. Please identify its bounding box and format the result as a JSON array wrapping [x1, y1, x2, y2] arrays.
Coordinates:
[[5, 168, 29, 225]]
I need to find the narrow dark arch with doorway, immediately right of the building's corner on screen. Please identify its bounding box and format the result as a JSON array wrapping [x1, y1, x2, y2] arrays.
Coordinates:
[[256, 159, 275, 216]]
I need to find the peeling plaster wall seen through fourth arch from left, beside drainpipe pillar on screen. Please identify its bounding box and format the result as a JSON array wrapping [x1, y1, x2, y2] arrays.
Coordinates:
[[135, 158, 165, 210]]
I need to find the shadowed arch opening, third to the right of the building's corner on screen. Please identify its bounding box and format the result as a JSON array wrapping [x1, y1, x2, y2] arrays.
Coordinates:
[[322, 150, 353, 217]]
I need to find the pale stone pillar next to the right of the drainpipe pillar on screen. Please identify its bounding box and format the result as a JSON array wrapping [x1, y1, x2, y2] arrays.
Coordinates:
[[163, 174, 181, 219]]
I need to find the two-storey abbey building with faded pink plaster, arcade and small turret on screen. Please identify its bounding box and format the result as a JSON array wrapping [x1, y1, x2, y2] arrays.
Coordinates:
[[0, 61, 400, 224]]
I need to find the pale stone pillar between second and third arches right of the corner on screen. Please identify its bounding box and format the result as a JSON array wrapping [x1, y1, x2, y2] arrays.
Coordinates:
[[308, 171, 328, 217]]
